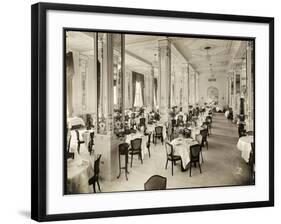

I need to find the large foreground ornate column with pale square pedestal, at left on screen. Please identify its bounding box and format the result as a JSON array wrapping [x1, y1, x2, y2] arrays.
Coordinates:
[[95, 33, 118, 181]]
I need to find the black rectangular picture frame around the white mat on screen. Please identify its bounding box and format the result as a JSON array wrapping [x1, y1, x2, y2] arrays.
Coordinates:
[[31, 3, 274, 221]]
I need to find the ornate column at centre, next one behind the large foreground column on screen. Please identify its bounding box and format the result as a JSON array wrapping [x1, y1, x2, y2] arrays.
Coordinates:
[[158, 39, 171, 122]]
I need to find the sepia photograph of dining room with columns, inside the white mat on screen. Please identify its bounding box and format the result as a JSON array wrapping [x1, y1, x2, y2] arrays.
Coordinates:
[[63, 29, 255, 194]]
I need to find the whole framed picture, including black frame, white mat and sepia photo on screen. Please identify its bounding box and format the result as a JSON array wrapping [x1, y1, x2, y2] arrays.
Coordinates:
[[32, 3, 274, 221]]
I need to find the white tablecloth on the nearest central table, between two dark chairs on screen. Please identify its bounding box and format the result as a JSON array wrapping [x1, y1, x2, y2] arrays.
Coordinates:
[[171, 138, 198, 168]]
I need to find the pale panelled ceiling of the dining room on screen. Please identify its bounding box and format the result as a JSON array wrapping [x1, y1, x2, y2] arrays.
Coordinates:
[[66, 31, 246, 75]]
